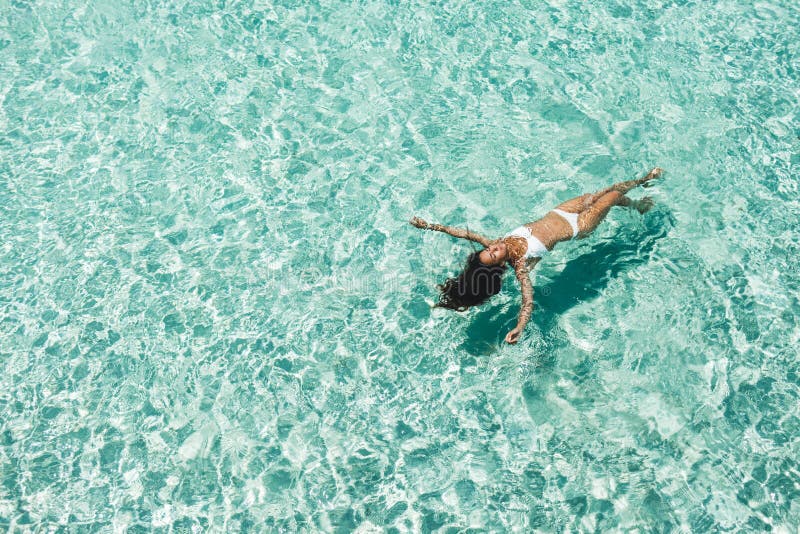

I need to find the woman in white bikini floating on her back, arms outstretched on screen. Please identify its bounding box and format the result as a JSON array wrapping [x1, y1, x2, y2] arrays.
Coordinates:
[[410, 167, 661, 343]]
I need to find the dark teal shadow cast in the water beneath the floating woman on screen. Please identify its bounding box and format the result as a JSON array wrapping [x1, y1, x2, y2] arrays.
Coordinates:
[[460, 208, 674, 363]]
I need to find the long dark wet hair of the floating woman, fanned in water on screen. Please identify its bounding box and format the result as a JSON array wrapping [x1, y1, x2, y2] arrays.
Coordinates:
[[436, 252, 506, 311]]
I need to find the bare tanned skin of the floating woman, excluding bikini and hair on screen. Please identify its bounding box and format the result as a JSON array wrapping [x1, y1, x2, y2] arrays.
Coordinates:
[[409, 167, 662, 343]]
